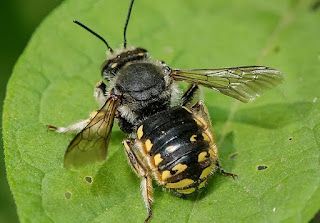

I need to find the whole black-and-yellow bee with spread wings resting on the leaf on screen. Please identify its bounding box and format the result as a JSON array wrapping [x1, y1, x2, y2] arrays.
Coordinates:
[[48, 0, 284, 222]]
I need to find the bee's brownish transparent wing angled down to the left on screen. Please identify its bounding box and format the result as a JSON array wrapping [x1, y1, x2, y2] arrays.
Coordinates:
[[64, 97, 119, 169]]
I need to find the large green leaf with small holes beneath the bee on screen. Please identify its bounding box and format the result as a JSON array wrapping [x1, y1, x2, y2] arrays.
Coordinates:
[[3, 0, 320, 222]]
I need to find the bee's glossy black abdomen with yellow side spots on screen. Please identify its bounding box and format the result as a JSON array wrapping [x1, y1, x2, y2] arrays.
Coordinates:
[[137, 106, 218, 194]]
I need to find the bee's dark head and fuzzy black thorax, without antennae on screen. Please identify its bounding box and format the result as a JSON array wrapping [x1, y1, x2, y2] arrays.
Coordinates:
[[102, 48, 175, 102]]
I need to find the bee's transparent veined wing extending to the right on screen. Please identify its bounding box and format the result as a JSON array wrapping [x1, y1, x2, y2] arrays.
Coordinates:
[[171, 66, 284, 102]]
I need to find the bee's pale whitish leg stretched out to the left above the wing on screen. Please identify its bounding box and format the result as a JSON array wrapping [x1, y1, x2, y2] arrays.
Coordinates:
[[47, 110, 98, 134]]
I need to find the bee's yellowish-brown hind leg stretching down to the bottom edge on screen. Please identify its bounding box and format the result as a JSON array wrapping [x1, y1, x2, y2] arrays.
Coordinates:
[[122, 139, 152, 223]]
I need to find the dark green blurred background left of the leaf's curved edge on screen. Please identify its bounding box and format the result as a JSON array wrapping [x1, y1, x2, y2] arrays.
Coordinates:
[[0, 0, 62, 223]]
